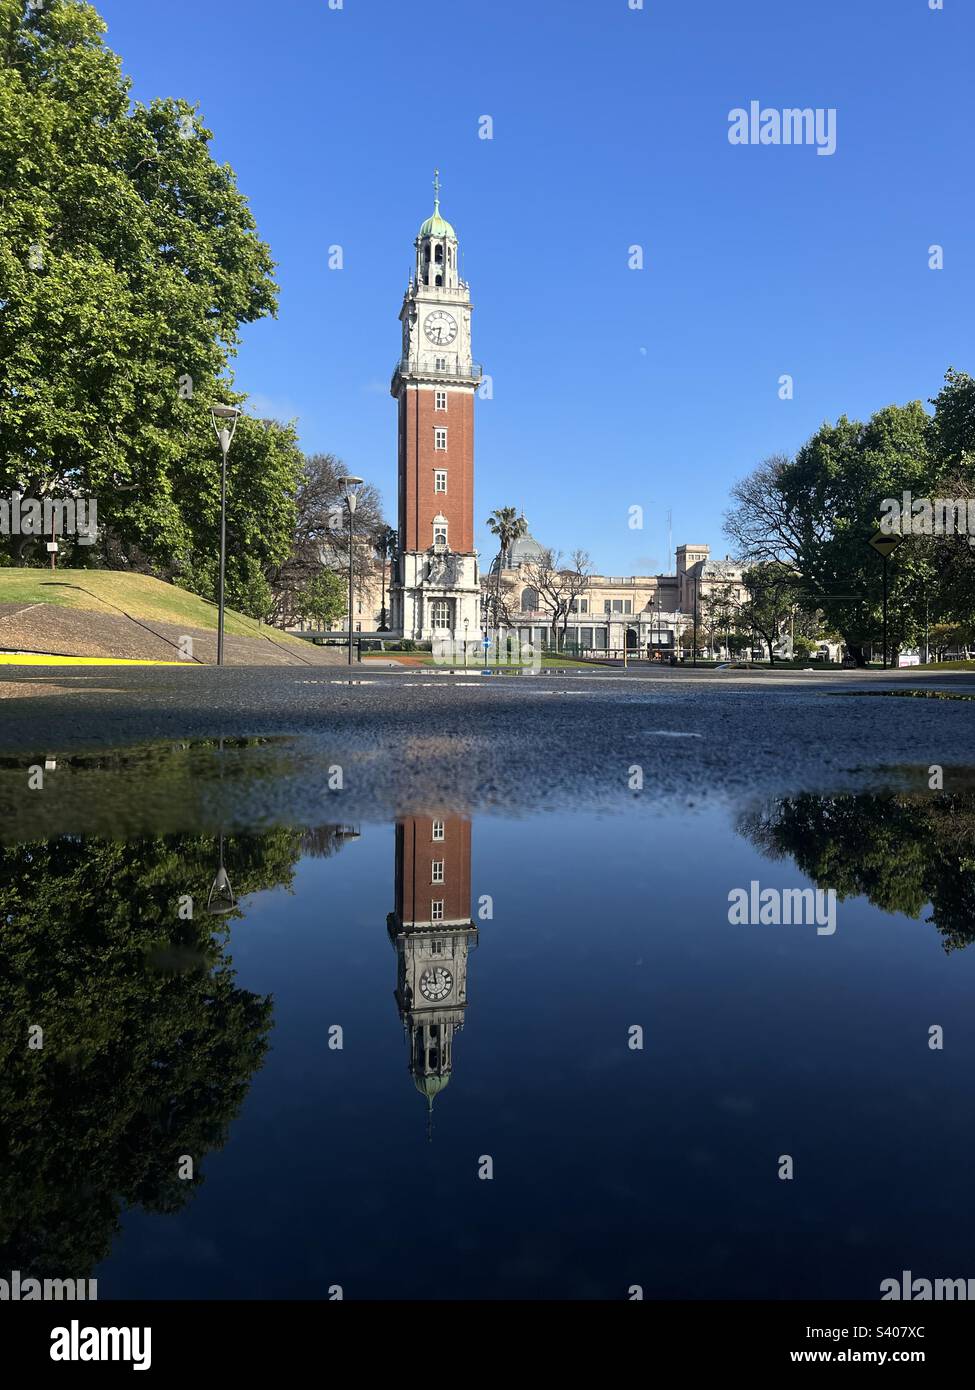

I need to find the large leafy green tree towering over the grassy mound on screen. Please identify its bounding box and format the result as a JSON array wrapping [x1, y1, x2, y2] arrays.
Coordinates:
[[0, 0, 296, 598]]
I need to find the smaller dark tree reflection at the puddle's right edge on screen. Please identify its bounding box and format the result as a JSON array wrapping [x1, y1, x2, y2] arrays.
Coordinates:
[[739, 791, 975, 951]]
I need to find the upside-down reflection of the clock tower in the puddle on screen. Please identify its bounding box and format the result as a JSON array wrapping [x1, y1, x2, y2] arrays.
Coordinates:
[[389, 816, 477, 1128]]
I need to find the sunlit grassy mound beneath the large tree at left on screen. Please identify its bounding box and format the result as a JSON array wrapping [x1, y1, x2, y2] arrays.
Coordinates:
[[0, 569, 296, 651]]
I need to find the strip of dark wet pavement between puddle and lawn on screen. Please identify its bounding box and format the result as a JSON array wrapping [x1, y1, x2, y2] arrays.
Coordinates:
[[0, 666, 975, 821]]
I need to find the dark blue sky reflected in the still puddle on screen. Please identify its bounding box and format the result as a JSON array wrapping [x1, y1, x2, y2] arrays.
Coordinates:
[[99, 810, 975, 1298]]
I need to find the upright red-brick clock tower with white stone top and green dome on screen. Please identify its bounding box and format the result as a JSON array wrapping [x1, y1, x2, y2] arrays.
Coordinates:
[[389, 179, 481, 641]]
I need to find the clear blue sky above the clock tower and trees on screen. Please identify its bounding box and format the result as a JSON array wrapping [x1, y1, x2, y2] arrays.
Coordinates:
[[96, 0, 975, 574]]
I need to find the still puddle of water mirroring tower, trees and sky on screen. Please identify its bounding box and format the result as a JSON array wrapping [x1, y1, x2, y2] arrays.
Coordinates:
[[0, 765, 975, 1300]]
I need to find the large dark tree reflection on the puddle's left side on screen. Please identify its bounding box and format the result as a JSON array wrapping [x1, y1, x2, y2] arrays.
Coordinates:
[[0, 830, 300, 1279]]
